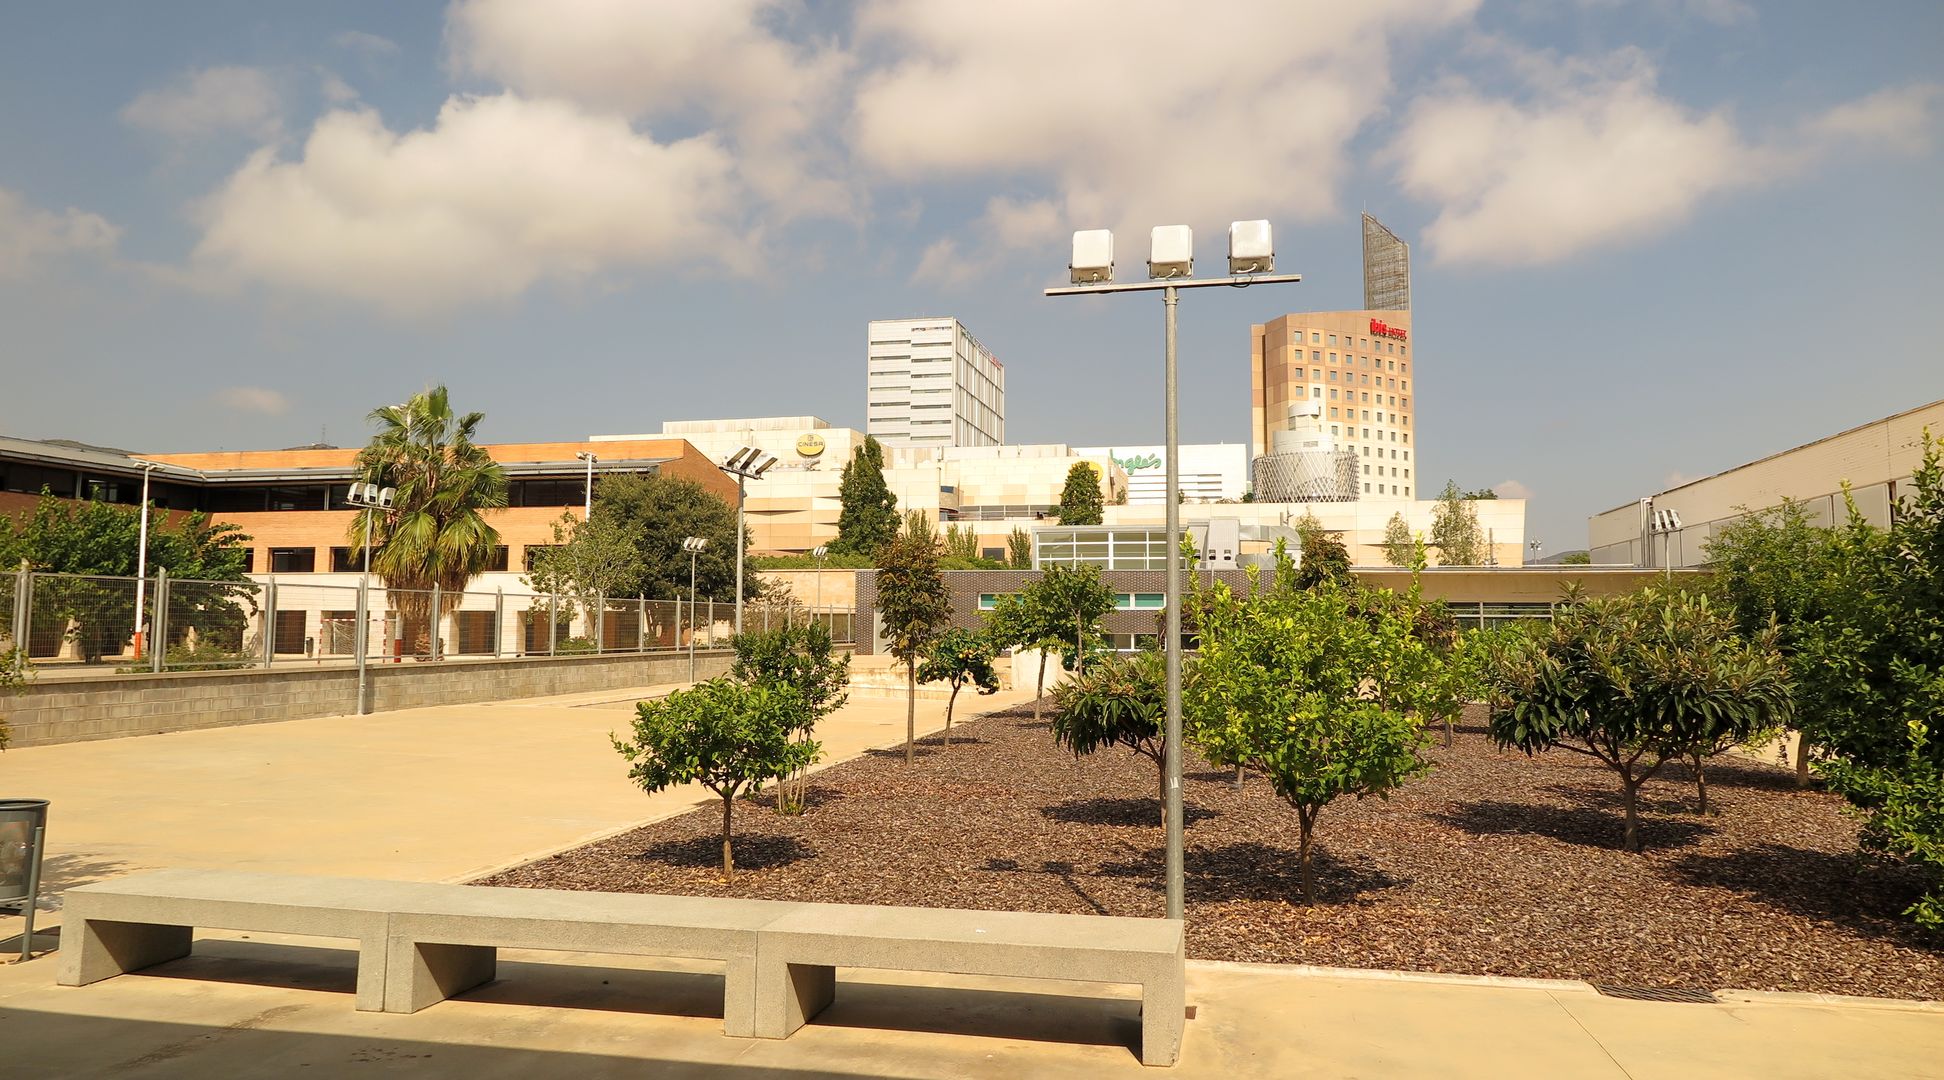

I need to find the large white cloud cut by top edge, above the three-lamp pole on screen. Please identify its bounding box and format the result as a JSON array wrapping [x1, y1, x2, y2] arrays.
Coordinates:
[[851, 0, 1475, 245]]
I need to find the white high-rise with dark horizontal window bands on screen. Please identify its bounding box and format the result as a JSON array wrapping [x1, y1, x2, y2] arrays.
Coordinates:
[[865, 317, 1005, 447]]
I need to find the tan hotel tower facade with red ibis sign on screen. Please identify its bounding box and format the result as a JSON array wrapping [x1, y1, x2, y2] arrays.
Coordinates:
[[1250, 309, 1419, 499]]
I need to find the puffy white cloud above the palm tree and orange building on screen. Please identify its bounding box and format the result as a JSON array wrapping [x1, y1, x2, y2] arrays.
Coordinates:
[[192, 93, 756, 313]]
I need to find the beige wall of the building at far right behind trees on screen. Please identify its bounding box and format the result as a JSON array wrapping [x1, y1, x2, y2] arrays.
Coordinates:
[[1586, 400, 1944, 567]]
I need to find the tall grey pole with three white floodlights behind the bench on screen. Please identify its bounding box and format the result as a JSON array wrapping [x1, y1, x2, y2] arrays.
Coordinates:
[[1046, 221, 1302, 919]]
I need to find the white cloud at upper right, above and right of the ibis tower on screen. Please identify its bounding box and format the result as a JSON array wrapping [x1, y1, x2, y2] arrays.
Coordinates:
[[1384, 51, 1932, 264]]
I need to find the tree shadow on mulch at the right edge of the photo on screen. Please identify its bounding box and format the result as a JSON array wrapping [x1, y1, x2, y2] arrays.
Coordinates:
[[1672, 843, 1944, 948]]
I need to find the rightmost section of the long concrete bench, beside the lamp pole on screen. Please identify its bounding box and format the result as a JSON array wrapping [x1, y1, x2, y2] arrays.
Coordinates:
[[756, 903, 1186, 1064]]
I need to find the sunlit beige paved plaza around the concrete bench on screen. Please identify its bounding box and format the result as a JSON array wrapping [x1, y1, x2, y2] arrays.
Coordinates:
[[0, 688, 1944, 1080]]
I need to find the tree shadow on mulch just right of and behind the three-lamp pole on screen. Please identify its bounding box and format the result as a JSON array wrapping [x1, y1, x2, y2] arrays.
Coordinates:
[[1096, 841, 1411, 903]]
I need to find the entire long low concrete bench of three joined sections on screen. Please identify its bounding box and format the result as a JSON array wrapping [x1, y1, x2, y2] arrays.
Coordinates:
[[56, 870, 1186, 1064]]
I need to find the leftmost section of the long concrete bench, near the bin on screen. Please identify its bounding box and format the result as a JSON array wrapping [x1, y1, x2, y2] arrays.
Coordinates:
[[56, 870, 441, 1012]]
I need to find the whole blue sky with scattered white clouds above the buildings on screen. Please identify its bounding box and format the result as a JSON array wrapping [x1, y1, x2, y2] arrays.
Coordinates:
[[0, 0, 1944, 552]]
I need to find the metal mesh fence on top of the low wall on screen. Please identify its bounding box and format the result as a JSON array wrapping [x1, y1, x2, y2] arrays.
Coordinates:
[[0, 571, 855, 678]]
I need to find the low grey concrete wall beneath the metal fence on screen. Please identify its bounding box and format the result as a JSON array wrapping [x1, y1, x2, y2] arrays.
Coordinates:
[[0, 649, 735, 746]]
